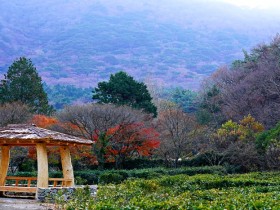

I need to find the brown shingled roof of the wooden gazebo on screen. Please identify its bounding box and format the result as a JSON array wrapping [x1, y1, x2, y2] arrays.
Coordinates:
[[0, 124, 92, 146]]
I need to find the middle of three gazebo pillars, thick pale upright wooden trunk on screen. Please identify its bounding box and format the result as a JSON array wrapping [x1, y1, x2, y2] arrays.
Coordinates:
[[36, 143, 49, 188]]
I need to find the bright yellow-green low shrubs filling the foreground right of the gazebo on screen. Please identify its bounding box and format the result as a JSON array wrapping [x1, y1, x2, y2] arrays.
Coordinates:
[[58, 172, 280, 209]]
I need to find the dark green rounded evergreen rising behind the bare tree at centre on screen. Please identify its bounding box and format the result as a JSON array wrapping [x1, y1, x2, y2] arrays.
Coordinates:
[[93, 71, 157, 116]]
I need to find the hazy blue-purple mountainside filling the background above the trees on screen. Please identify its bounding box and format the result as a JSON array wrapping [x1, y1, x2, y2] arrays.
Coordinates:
[[0, 0, 280, 89]]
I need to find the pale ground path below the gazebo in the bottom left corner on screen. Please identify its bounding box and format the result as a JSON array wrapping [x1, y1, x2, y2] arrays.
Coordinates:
[[0, 198, 54, 210]]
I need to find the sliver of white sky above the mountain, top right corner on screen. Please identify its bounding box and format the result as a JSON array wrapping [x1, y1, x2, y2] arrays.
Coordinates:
[[221, 0, 280, 9]]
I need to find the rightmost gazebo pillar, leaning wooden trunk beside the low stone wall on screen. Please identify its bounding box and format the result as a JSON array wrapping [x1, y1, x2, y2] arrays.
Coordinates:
[[60, 146, 74, 187]]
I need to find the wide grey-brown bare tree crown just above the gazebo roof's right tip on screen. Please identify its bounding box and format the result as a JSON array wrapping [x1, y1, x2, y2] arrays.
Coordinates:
[[57, 104, 152, 140]]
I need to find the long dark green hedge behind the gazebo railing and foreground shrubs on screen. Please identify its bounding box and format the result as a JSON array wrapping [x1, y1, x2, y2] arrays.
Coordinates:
[[10, 166, 226, 185]]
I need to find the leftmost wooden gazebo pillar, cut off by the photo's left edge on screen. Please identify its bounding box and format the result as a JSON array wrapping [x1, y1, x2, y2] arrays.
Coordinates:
[[0, 146, 10, 186]]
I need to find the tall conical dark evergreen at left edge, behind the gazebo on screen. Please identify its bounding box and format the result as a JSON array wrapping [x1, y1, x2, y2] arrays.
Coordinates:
[[0, 57, 53, 114]]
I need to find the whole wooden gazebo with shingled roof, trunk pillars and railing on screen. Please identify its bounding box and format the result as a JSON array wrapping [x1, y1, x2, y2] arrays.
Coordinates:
[[0, 124, 92, 193]]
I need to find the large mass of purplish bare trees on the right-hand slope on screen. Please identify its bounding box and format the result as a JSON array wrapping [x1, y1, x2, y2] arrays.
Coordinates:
[[199, 35, 280, 128]]
